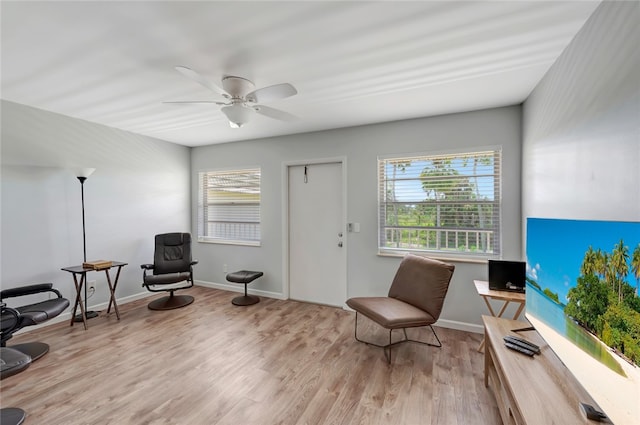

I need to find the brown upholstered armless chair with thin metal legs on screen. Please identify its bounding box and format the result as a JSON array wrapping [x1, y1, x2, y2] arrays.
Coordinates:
[[347, 254, 455, 363]]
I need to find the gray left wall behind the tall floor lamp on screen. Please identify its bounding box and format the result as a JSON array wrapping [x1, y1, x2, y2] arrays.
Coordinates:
[[0, 101, 191, 308]]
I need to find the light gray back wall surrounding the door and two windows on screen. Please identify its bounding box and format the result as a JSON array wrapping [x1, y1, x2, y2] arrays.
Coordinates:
[[191, 106, 522, 330]]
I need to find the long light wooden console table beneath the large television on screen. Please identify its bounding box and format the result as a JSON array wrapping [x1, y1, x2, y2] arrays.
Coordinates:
[[482, 316, 598, 425]]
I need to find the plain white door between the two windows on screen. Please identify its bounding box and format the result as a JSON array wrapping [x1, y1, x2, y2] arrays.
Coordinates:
[[289, 162, 347, 307]]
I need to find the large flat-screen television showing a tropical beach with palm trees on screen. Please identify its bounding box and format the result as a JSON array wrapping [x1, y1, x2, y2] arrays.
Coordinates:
[[523, 218, 640, 425]]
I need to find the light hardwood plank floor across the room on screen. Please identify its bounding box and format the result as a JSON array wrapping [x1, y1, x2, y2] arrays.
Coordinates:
[[0, 287, 501, 425]]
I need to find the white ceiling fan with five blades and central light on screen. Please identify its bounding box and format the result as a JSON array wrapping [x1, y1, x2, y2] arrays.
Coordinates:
[[164, 66, 298, 128]]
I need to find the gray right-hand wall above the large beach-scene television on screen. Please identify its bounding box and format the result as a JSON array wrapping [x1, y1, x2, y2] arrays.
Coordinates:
[[522, 2, 640, 224]]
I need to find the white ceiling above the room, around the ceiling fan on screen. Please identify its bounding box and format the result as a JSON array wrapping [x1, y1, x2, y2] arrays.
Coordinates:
[[0, 0, 599, 146]]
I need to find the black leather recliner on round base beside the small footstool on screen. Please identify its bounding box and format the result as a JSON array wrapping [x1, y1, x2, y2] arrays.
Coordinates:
[[140, 233, 198, 310]]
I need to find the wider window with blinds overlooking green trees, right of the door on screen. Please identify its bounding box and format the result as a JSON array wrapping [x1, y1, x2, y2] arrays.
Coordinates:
[[378, 149, 501, 258]]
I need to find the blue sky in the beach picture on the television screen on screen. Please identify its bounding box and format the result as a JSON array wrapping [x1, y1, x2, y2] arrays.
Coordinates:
[[527, 218, 640, 303]]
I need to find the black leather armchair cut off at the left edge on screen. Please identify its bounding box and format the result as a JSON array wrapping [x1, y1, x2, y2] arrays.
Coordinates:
[[0, 283, 69, 361]]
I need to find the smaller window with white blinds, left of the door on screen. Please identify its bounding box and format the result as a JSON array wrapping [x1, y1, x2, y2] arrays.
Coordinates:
[[198, 169, 260, 245]]
